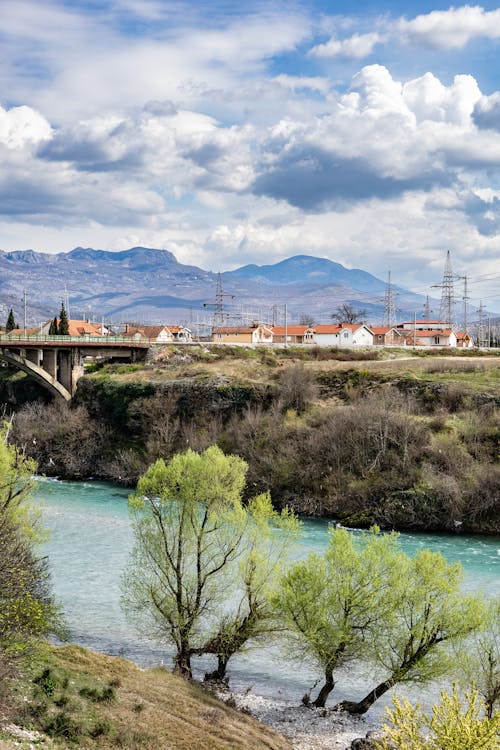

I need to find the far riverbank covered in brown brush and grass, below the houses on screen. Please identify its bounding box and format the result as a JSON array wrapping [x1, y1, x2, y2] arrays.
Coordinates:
[[10, 347, 500, 534]]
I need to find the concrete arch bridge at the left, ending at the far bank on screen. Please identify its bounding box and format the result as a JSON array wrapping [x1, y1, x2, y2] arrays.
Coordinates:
[[0, 334, 148, 401]]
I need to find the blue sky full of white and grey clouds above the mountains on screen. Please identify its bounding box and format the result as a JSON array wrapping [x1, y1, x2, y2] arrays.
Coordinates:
[[0, 0, 500, 311]]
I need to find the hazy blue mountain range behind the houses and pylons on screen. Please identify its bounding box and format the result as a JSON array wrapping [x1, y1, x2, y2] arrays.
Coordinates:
[[0, 247, 439, 326]]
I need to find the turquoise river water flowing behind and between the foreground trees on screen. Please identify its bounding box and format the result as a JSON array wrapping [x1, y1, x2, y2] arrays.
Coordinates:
[[35, 479, 500, 714]]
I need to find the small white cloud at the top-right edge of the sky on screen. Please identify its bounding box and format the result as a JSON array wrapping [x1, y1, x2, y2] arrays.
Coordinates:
[[395, 5, 500, 49]]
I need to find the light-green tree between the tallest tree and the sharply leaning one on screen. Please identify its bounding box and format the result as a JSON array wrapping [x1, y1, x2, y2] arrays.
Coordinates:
[[274, 529, 402, 707]]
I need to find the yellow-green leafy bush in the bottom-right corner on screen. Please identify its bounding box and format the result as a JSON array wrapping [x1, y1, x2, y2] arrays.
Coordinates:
[[375, 687, 500, 750]]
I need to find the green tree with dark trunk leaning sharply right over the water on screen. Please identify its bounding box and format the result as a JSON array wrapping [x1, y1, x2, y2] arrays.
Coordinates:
[[336, 549, 485, 714]]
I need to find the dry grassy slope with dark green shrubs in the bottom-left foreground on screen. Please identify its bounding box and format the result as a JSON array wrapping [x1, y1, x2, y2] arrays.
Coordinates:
[[0, 646, 290, 750]]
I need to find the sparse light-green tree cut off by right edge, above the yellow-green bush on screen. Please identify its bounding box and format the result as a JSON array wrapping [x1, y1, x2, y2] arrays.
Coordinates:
[[455, 597, 500, 718]]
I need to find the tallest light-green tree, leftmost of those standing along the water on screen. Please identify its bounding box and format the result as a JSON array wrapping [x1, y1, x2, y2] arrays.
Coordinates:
[[122, 446, 296, 677]]
